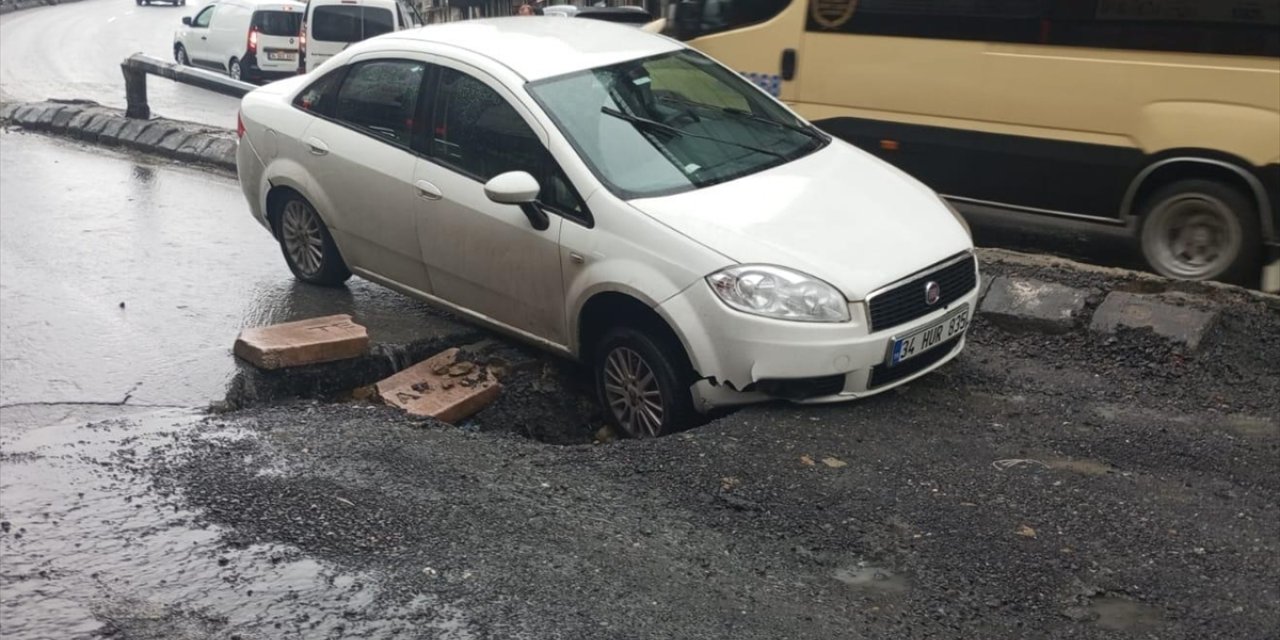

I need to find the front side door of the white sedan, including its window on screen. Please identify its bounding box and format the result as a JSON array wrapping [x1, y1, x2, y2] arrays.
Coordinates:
[[413, 63, 585, 346]]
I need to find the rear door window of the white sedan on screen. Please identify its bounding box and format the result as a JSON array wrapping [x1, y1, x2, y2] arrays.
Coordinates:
[[333, 60, 426, 147]]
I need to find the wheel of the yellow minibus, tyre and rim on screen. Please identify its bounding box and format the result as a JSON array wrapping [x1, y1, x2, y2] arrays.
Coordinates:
[[1138, 179, 1262, 284]]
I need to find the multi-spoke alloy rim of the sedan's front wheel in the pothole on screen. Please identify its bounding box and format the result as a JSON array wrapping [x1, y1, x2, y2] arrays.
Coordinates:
[[604, 347, 666, 438]]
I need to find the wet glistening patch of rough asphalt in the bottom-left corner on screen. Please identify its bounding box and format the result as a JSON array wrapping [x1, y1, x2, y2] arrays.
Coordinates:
[[0, 411, 472, 640]]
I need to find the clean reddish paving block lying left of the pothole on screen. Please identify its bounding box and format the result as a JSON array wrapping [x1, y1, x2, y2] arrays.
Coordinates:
[[234, 314, 369, 369]]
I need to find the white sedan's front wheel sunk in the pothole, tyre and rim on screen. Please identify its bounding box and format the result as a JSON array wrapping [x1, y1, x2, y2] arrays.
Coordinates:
[[591, 326, 698, 438]]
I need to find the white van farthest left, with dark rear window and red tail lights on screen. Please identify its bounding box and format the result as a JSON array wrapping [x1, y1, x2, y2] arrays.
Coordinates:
[[173, 0, 306, 82]]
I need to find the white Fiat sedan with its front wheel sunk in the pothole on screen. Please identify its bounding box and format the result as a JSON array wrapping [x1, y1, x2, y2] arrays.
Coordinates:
[[237, 18, 978, 436]]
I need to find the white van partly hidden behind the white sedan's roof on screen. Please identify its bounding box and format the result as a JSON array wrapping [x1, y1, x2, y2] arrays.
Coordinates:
[[298, 0, 426, 73]]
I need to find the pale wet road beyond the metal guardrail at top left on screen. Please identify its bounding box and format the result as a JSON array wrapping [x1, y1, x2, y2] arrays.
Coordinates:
[[0, 0, 239, 128]]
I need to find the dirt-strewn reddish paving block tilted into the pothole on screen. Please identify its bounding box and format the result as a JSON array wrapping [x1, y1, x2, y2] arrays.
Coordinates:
[[375, 348, 502, 424]]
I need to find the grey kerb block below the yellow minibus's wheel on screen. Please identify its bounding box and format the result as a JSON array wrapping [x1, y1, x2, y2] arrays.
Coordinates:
[[1089, 291, 1217, 351]]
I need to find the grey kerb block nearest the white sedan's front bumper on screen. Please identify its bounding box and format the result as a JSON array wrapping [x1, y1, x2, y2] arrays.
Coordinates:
[[979, 278, 1088, 333]]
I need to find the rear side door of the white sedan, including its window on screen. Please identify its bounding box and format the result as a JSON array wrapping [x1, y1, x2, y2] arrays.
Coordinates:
[[298, 55, 431, 293]]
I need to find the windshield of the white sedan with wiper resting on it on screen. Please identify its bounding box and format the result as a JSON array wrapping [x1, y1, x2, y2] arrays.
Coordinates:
[[530, 50, 829, 198]]
